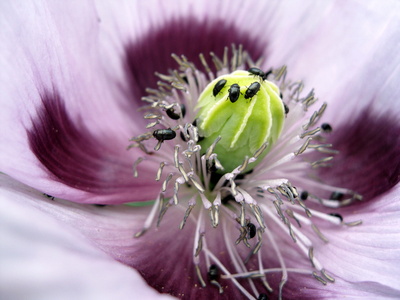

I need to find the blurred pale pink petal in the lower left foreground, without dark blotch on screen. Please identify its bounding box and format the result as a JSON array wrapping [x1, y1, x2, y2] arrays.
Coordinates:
[[0, 176, 172, 300]]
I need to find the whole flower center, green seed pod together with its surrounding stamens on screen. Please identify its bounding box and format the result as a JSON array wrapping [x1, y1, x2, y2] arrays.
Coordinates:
[[129, 47, 362, 299]]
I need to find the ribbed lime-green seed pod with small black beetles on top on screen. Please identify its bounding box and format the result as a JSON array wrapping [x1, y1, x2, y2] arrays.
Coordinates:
[[196, 71, 285, 172]]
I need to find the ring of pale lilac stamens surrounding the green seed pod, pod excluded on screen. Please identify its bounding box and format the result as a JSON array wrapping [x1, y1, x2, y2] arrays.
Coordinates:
[[129, 46, 362, 299]]
